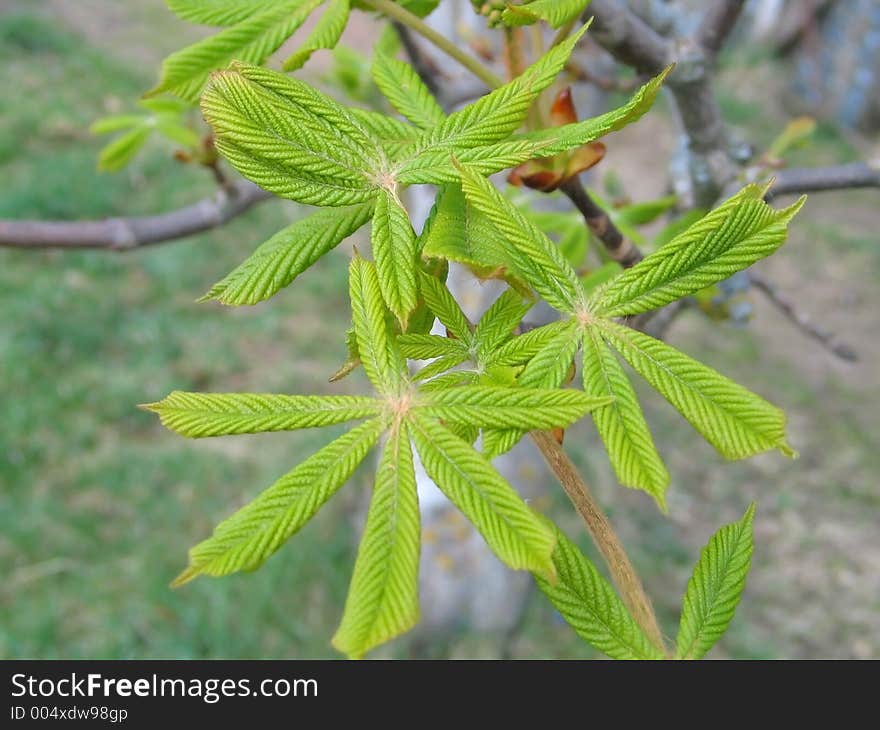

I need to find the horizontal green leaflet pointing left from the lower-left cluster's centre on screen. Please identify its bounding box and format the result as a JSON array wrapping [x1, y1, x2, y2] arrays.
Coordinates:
[[144, 390, 381, 438]]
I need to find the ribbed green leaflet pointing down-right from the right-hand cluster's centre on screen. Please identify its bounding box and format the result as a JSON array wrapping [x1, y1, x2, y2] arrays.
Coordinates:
[[599, 321, 795, 459]]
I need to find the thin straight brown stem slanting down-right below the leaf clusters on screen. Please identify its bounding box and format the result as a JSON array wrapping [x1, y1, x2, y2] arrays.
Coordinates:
[[531, 431, 666, 652]]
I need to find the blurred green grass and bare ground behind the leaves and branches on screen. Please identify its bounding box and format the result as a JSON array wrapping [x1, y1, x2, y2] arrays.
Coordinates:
[[0, 0, 880, 658]]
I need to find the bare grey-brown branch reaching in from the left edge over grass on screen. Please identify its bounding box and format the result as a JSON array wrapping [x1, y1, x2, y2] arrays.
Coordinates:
[[0, 180, 272, 251]]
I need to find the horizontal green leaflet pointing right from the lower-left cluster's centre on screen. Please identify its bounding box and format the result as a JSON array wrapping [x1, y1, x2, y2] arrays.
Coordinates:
[[419, 385, 611, 431]]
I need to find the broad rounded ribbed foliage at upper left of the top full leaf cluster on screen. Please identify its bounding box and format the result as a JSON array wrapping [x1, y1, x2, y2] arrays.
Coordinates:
[[202, 64, 383, 207]]
